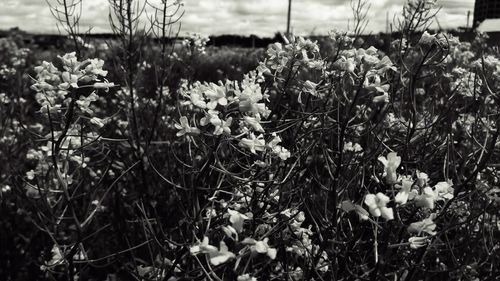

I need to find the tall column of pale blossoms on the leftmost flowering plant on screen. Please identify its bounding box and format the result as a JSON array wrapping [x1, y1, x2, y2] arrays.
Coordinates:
[[26, 53, 114, 200]]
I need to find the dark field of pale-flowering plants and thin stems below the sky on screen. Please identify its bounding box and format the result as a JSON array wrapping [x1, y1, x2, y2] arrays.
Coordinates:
[[0, 0, 500, 281]]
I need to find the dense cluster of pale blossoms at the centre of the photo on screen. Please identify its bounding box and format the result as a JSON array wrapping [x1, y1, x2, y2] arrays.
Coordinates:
[[176, 69, 290, 160]]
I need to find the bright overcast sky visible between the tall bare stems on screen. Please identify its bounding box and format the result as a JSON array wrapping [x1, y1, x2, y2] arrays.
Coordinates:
[[0, 0, 474, 36]]
